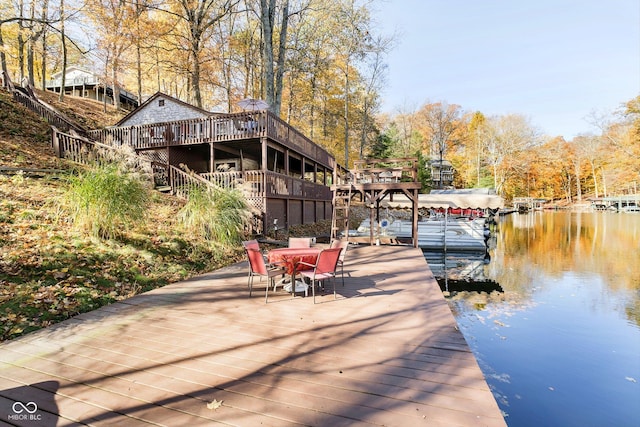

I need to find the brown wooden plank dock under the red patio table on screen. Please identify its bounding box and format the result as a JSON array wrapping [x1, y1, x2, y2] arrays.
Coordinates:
[[0, 246, 506, 427]]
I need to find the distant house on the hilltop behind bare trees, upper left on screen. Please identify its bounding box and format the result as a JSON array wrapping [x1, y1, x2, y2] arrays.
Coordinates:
[[46, 67, 138, 110]]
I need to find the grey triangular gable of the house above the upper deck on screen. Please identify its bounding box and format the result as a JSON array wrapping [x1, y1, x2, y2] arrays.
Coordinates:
[[116, 92, 214, 127]]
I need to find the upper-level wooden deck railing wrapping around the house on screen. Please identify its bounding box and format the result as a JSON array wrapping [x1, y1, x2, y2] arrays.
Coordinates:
[[88, 111, 335, 169]]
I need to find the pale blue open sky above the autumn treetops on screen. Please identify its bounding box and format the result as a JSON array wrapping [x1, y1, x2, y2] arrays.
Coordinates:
[[373, 0, 640, 140]]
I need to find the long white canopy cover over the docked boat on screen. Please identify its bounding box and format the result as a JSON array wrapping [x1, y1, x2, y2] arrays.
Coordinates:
[[380, 192, 504, 209]]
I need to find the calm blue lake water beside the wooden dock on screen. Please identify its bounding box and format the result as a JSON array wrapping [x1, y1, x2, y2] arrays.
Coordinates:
[[426, 212, 640, 427]]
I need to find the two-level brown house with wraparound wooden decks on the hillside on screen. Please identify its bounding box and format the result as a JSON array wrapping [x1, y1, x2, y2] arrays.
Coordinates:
[[84, 93, 336, 233]]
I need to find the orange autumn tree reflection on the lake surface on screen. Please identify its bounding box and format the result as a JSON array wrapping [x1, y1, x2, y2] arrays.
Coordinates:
[[485, 212, 640, 326]]
